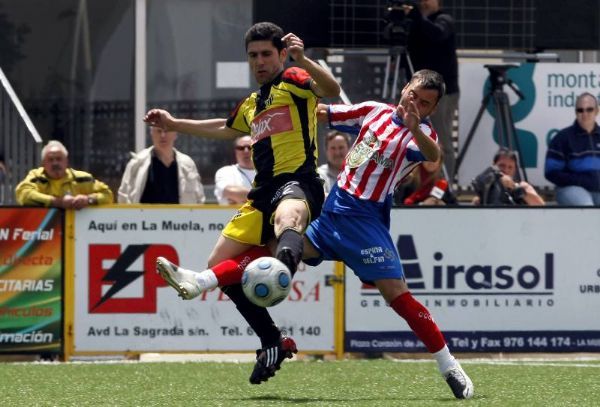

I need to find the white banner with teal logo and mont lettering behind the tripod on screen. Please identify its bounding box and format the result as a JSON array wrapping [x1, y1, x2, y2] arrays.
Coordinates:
[[458, 63, 600, 186]]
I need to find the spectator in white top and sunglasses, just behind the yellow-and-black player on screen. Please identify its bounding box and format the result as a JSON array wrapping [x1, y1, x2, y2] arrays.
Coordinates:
[[215, 136, 256, 205]]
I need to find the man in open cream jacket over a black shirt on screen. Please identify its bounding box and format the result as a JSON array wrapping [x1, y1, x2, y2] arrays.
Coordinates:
[[118, 127, 205, 204]]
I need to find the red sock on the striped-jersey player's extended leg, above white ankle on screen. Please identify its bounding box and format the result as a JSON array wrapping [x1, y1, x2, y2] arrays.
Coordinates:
[[390, 292, 446, 353]]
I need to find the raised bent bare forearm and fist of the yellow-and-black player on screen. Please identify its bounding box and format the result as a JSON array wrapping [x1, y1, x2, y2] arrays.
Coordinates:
[[281, 33, 340, 97]]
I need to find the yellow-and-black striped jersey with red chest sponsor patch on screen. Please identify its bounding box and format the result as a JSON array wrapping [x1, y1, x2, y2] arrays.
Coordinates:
[[227, 68, 318, 187]]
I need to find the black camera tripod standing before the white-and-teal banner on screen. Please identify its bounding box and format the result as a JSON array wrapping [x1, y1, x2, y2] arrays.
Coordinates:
[[454, 64, 527, 181]]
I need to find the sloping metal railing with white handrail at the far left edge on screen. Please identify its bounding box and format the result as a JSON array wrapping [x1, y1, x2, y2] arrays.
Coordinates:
[[0, 68, 42, 205]]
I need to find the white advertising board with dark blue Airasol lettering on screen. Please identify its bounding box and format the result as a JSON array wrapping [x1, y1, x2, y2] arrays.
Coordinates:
[[345, 208, 600, 352]]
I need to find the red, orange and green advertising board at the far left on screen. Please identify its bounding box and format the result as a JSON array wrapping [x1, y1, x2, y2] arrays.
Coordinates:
[[0, 207, 63, 353]]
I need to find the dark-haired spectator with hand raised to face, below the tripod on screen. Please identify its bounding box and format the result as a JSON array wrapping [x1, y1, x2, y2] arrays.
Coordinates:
[[473, 147, 545, 205]]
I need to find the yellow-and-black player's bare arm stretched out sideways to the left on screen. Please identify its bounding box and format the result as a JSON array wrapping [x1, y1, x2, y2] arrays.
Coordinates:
[[144, 109, 242, 139]]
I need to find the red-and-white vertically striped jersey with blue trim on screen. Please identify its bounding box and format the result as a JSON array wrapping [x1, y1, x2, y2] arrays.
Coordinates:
[[329, 102, 437, 202]]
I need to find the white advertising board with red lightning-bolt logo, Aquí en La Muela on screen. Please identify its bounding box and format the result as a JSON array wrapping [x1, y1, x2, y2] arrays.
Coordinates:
[[74, 207, 334, 353]]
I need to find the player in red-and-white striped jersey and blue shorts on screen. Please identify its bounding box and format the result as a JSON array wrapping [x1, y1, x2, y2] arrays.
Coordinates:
[[304, 70, 473, 398]]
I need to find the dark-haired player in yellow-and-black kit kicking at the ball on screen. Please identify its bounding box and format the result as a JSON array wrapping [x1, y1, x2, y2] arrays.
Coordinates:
[[144, 22, 340, 384]]
